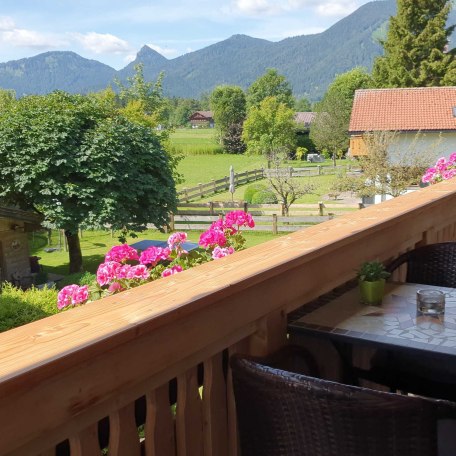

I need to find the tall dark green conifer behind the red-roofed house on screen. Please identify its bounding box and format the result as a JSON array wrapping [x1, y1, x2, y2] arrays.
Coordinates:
[[372, 0, 456, 87]]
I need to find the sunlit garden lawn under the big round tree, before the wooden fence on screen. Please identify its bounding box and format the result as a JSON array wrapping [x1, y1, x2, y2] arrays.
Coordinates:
[[30, 229, 279, 275]]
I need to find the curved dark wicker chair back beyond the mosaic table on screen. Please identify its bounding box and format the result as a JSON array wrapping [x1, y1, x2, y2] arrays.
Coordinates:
[[387, 242, 456, 287]]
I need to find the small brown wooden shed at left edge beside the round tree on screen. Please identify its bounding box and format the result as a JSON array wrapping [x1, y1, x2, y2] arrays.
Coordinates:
[[0, 206, 42, 285]]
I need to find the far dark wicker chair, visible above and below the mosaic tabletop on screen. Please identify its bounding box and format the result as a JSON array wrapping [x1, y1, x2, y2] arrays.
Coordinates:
[[353, 242, 456, 401]]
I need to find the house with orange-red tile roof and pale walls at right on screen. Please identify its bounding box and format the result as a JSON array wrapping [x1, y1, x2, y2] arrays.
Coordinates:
[[349, 87, 456, 157]]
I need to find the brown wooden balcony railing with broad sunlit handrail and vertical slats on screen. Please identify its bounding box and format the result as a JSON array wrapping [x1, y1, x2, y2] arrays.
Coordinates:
[[0, 180, 456, 456]]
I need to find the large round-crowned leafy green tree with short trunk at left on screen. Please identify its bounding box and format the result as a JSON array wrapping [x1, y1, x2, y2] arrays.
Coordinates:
[[0, 92, 176, 272]]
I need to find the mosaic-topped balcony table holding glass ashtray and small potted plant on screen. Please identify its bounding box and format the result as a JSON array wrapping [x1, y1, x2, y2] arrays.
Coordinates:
[[288, 283, 456, 380]]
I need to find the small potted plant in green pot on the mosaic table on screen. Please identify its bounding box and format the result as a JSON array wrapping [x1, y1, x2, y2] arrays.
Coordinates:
[[356, 260, 391, 305]]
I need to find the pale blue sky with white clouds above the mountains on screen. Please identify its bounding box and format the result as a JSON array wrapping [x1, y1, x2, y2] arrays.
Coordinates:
[[0, 0, 374, 69]]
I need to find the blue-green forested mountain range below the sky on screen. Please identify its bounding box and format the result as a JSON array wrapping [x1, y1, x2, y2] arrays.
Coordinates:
[[0, 0, 456, 101]]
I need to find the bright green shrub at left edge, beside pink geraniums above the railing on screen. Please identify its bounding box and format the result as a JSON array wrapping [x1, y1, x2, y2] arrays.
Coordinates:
[[0, 283, 57, 332]]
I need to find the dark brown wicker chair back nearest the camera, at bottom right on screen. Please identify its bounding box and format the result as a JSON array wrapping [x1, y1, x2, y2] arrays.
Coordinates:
[[230, 355, 456, 456]]
